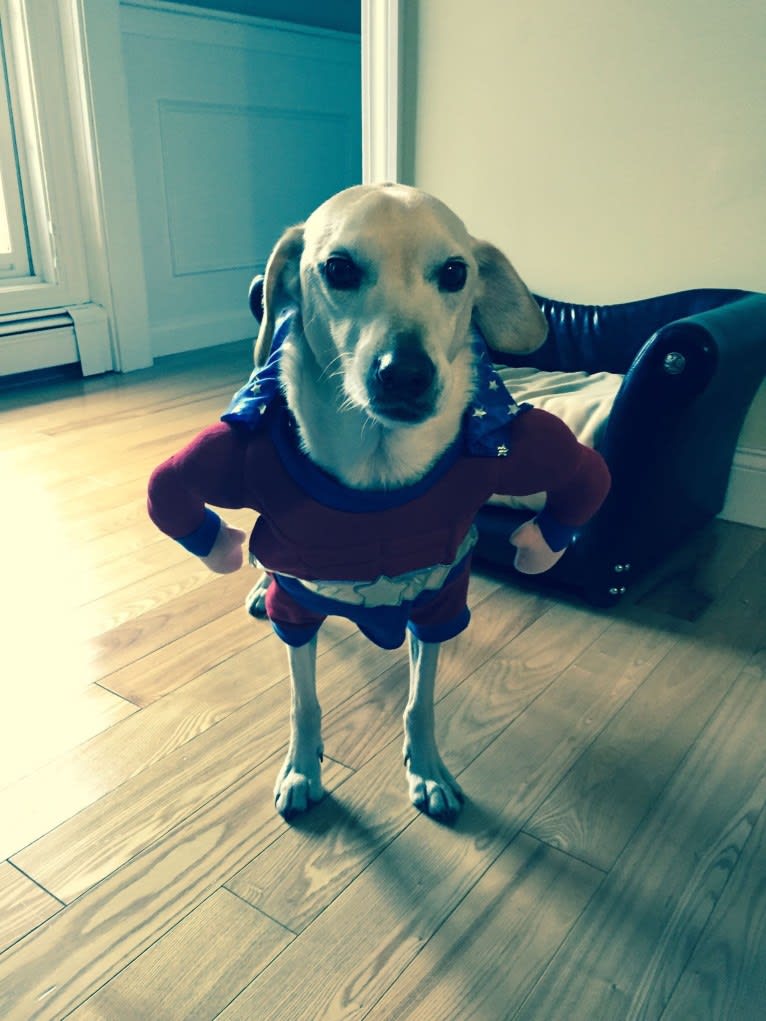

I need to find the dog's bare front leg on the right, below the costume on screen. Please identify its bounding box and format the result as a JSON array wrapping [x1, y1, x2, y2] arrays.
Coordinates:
[[404, 633, 464, 822]]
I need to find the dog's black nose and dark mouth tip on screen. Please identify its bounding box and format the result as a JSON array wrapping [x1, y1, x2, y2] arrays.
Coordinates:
[[367, 347, 438, 423]]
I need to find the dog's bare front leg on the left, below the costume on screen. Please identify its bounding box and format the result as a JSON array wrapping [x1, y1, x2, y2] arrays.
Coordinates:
[[274, 636, 324, 819]]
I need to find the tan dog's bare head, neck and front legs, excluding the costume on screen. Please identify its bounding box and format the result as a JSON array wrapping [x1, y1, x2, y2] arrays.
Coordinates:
[[240, 185, 547, 819]]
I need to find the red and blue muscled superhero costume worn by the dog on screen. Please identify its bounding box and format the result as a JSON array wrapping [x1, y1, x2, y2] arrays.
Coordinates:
[[149, 322, 609, 647]]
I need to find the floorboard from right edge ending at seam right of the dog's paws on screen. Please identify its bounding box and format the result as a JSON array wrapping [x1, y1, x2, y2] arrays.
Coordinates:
[[528, 548, 766, 869]]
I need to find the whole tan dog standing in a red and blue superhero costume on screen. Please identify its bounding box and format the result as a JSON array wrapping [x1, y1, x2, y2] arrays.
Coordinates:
[[149, 185, 609, 822]]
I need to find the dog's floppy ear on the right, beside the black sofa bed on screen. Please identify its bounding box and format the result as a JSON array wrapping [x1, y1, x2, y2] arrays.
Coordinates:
[[473, 240, 547, 354]]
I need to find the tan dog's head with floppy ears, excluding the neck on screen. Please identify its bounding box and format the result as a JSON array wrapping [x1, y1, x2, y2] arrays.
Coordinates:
[[255, 185, 546, 426]]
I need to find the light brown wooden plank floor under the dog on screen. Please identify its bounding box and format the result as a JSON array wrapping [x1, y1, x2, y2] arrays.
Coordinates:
[[0, 345, 766, 1021]]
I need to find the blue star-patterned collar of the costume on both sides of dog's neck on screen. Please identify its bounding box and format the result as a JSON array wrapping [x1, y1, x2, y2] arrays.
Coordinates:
[[221, 312, 530, 457]]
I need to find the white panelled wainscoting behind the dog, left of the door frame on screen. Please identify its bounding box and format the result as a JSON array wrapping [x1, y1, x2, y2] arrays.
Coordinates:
[[122, 7, 362, 357]]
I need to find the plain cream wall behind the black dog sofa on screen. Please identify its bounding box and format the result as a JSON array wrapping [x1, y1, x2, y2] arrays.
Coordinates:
[[401, 0, 766, 450]]
